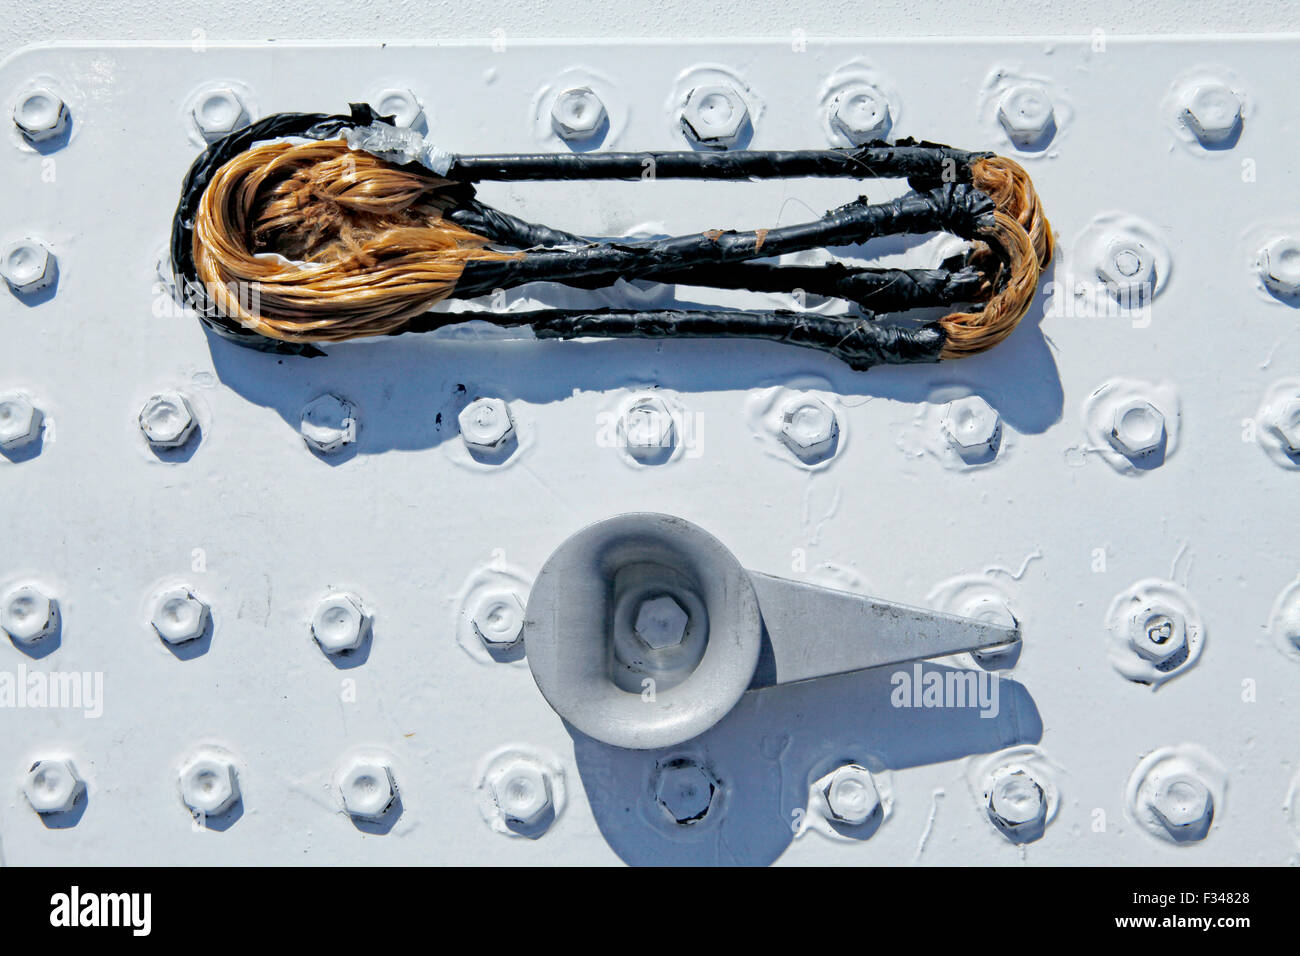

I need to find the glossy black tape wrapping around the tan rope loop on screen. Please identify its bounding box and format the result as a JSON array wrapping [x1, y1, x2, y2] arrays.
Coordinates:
[[170, 104, 993, 369]]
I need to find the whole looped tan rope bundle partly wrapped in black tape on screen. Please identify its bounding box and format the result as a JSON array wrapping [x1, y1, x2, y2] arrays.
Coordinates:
[[172, 107, 1052, 368]]
